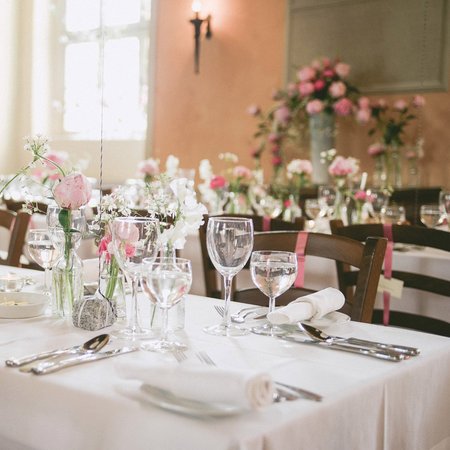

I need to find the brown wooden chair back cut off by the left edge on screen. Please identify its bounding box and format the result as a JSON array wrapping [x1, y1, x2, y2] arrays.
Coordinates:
[[0, 209, 31, 267]]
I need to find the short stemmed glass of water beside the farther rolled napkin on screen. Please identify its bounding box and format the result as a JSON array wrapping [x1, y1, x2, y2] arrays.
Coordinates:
[[250, 250, 297, 336]]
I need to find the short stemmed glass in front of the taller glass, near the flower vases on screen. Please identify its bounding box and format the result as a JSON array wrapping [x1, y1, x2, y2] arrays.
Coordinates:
[[141, 258, 192, 353]]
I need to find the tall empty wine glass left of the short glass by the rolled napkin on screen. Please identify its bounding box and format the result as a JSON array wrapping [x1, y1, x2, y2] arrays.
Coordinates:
[[204, 217, 253, 336]]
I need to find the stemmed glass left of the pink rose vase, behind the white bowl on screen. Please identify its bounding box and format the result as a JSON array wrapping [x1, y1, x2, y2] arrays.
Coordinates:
[[27, 229, 62, 294]]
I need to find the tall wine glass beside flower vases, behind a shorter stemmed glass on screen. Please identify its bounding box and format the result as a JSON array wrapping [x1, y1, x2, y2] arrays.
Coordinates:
[[112, 217, 159, 339]]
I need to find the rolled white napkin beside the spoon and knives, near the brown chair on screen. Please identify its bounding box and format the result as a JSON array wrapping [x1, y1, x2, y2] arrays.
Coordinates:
[[267, 288, 345, 325]]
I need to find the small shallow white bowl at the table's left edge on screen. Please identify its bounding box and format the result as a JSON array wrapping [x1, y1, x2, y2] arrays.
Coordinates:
[[0, 292, 49, 319]]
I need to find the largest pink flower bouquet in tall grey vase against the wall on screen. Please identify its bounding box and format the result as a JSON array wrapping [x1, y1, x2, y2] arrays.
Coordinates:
[[249, 58, 358, 184]]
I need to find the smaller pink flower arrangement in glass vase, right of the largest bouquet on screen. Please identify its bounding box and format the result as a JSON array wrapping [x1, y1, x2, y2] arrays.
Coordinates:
[[357, 95, 425, 189]]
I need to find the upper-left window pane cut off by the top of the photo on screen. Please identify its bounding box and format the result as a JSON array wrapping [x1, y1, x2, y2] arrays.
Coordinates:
[[66, 0, 100, 31]]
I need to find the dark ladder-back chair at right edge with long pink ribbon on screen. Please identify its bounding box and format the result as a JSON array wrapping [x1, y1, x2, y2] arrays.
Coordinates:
[[330, 220, 450, 337]]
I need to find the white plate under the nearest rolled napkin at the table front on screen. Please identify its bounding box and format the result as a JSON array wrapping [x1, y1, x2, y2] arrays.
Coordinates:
[[141, 384, 244, 417]]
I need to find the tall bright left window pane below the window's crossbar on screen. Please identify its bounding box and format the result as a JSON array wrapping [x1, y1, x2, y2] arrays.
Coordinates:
[[64, 42, 100, 134]]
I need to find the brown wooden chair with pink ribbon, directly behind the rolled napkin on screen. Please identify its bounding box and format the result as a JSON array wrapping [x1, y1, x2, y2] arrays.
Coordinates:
[[233, 231, 387, 323]]
